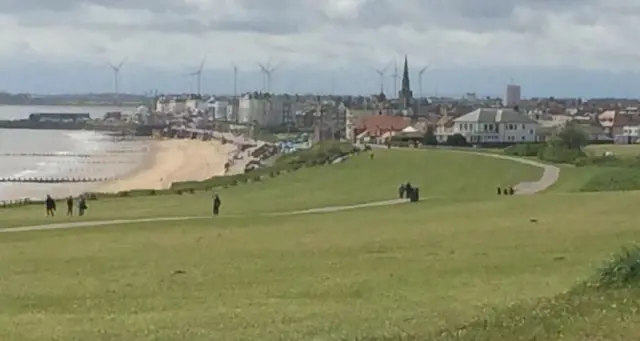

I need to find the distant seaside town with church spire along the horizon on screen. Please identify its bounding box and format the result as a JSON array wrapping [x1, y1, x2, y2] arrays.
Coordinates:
[[0, 60, 640, 145]]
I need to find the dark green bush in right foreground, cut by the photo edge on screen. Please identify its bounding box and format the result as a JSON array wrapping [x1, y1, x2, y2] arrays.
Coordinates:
[[593, 246, 640, 289]]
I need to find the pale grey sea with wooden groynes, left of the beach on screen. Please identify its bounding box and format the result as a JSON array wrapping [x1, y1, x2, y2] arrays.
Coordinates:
[[0, 105, 151, 202]]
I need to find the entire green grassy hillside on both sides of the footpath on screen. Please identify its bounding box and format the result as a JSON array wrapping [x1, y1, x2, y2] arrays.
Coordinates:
[[0, 150, 640, 341]]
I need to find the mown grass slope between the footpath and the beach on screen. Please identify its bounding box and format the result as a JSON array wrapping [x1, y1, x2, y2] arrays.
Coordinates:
[[0, 149, 542, 227]]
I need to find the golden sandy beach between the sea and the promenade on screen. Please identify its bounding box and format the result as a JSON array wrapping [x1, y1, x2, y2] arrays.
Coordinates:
[[96, 139, 235, 192]]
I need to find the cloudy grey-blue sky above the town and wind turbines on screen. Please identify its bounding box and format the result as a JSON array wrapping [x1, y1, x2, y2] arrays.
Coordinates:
[[0, 0, 640, 97]]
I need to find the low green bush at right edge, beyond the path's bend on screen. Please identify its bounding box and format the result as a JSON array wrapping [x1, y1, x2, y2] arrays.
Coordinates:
[[580, 168, 640, 192]]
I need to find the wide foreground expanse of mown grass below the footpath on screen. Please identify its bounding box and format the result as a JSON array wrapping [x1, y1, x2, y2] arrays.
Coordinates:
[[0, 192, 640, 341]]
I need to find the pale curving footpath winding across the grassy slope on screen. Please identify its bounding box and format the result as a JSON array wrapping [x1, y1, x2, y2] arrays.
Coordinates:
[[0, 151, 560, 233]]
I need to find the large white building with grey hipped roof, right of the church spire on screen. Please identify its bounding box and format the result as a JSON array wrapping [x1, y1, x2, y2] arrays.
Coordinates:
[[452, 108, 539, 144]]
